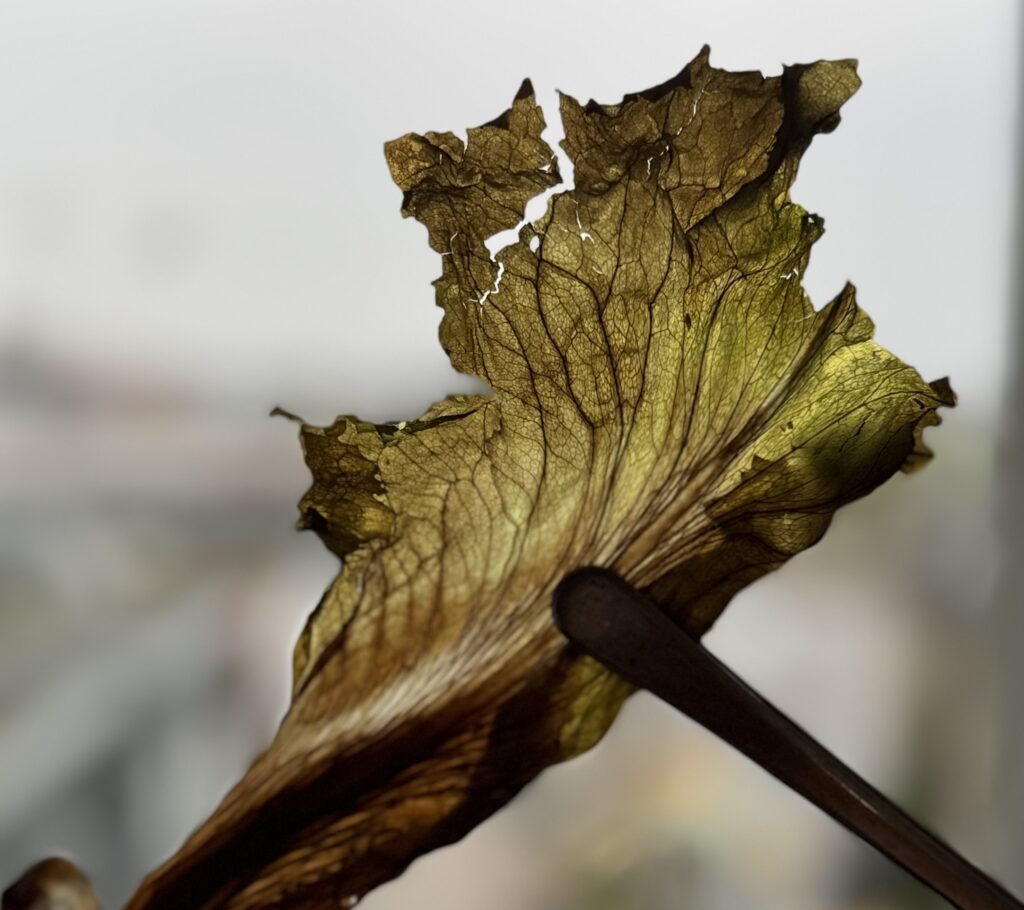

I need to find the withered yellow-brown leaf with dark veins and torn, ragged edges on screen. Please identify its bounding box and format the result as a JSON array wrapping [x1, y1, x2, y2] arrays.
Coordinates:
[[129, 49, 952, 908]]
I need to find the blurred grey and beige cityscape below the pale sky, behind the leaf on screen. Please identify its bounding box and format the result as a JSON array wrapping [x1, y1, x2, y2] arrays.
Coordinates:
[[0, 343, 1024, 910]]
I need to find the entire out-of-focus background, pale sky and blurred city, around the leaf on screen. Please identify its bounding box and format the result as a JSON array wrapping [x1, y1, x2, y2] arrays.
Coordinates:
[[0, 0, 1024, 910]]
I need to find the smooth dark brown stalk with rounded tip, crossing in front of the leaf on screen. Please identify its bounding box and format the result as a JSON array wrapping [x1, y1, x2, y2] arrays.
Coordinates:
[[554, 569, 1024, 910]]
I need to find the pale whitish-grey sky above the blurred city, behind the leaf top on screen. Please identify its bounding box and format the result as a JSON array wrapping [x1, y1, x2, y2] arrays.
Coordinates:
[[0, 0, 1019, 421]]
